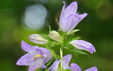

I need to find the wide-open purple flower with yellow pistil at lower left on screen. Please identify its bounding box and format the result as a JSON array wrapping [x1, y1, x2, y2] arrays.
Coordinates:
[[16, 41, 52, 71]]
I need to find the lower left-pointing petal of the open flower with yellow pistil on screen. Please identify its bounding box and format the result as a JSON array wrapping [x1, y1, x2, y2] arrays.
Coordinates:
[[16, 53, 35, 66]]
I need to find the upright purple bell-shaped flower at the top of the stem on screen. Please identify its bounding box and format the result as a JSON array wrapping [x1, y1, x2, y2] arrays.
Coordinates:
[[59, 1, 87, 33]]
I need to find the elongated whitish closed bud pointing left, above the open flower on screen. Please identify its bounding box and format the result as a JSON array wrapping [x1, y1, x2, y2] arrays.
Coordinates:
[[29, 34, 48, 44]]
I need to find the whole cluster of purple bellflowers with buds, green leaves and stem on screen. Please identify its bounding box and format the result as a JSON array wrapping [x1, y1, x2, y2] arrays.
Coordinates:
[[16, 1, 97, 71]]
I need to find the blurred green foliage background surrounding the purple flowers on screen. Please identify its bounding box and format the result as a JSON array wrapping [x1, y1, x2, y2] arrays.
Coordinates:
[[0, 0, 113, 71]]
